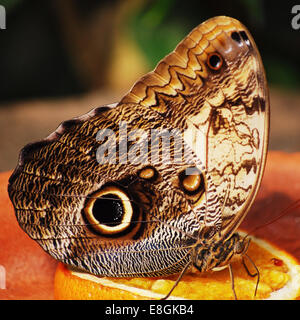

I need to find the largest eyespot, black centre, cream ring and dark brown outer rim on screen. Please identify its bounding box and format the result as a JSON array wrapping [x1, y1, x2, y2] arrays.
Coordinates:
[[83, 185, 141, 239]]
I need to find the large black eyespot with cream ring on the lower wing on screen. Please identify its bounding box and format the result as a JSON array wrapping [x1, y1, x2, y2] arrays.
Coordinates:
[[84, 186, 134, 236]]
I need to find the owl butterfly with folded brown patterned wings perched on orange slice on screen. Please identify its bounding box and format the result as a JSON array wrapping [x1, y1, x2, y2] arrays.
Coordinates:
[[8, 17, 269, 298]]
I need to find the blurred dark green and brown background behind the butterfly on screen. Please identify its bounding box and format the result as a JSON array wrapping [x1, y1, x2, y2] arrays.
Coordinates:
[[0, 0, 300, 171]]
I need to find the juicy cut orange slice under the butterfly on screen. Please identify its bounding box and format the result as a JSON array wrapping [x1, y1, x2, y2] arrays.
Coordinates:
[[54, 232, 300, 300]]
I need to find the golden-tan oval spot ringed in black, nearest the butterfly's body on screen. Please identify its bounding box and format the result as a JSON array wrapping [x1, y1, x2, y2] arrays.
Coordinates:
[[179, 167, 205, 195]]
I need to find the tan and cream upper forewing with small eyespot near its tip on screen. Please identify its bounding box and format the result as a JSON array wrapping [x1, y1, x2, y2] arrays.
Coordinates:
[[120, 16, 269, 239]]
